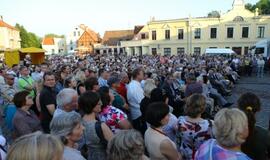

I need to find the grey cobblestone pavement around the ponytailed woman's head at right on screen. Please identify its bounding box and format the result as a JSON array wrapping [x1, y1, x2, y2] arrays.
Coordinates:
[[228, 75, 270, 129]]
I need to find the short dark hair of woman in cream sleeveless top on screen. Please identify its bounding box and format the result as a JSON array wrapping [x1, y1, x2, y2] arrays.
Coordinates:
[[145, 102, 169, 128]]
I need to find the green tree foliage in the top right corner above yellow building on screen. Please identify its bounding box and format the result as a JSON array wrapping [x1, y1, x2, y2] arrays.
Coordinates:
[[246, 0, 270, 14]]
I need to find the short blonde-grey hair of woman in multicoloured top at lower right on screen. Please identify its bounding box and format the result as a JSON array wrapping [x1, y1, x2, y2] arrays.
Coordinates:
[[213, 108, 248, 147]]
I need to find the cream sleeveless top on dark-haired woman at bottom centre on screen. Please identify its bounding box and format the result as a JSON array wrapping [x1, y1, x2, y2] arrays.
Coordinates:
[[144, 127, 176, 160]]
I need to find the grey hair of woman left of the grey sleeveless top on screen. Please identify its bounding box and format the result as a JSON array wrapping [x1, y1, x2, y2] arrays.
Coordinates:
[[50, 112, 81, 140]]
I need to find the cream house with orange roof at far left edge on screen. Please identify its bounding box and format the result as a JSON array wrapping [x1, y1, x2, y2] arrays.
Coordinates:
[[0, 16, 21, 51]]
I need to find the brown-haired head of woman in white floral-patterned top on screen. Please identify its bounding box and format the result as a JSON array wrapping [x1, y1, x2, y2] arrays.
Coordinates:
[[185, 94, 206, 118]]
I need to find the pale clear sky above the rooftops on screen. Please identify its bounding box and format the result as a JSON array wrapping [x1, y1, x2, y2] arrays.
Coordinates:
[[0, 0, 258, 37]]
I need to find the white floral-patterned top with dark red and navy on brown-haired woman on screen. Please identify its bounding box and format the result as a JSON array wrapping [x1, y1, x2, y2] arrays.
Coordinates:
[[176, 116, 212, 160]]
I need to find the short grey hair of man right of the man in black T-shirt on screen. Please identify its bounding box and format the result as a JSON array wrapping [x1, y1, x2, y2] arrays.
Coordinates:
[[56, 88, 77, 109]]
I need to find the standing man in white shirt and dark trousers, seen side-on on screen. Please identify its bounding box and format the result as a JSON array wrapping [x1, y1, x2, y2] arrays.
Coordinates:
[[127, 68, 146, 134]]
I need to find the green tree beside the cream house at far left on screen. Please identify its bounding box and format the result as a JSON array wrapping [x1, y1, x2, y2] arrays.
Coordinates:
[[15, 24, 41, 48]]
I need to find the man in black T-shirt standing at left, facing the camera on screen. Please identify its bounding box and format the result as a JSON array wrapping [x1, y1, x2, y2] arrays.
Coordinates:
[[39, 72, 56, 133]]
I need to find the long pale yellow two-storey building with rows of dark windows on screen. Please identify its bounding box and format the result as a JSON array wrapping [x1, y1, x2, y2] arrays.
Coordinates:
[[121, 0, 270, 55]]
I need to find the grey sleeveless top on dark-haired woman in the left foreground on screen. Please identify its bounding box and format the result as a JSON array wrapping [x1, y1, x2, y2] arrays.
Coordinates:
[[83, 121, 106, 160]]
